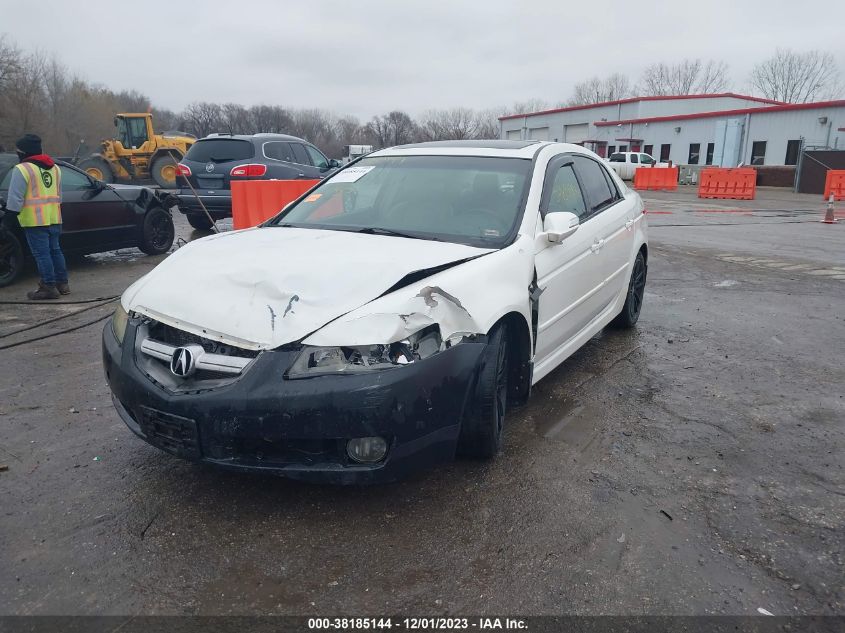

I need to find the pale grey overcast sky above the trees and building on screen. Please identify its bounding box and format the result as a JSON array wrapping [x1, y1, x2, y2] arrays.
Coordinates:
[[0, 0, 845, 119]]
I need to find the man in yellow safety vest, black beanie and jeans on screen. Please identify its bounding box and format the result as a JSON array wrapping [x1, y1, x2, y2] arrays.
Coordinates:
[[6, 134, 70, 301]]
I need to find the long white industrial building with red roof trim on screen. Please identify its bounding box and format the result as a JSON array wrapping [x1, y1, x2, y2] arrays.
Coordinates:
[[499, 93, 845, 167]]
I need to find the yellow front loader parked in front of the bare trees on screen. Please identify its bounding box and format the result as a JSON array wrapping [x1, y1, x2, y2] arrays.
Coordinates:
[[78, 113, 196, 189]]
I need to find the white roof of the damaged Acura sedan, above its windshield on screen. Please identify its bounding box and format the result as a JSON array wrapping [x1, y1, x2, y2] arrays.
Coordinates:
[[367, 139, 590, 159]]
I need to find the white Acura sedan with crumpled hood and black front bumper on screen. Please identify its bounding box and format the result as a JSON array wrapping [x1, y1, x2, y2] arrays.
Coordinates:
[[103, 141, 648, 483]]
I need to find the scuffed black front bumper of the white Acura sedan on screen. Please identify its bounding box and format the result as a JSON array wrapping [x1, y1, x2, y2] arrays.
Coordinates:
[[103, 322, 486, 483]]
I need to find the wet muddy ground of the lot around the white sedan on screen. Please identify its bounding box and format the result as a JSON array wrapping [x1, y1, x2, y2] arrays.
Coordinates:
[[0, 190, 845, 615]]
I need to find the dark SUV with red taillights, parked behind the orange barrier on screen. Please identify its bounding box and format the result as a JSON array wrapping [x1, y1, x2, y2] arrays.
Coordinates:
[[176, 134, 340, 229]]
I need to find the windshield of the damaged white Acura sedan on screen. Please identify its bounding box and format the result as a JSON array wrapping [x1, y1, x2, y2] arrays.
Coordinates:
[[270, 156, 531, 248]]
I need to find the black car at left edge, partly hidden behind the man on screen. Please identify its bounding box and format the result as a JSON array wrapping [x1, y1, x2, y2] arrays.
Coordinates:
[[0, 154, 176, 287]]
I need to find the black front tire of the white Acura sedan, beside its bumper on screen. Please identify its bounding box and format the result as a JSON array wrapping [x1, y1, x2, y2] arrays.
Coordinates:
[[458, 325, 510, 459]]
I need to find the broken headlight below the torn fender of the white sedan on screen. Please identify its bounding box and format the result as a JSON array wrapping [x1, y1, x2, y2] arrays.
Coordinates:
[[287, 327, 462, 378]]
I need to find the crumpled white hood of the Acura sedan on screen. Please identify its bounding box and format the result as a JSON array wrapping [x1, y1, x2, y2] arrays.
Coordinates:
[[122, 227, 490, 349]]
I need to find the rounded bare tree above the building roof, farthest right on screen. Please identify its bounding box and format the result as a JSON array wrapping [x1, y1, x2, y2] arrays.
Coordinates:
[[751, 48, 842, 103]]
